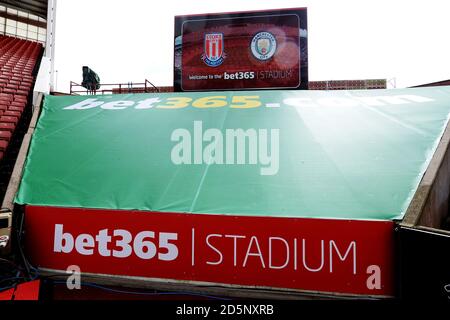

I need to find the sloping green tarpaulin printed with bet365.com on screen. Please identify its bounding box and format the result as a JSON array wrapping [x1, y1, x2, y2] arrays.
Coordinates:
[[16, 87, 450, 220]]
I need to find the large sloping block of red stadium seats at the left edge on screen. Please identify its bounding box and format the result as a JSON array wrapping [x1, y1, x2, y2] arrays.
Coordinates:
[[0, 35, 42, 160]]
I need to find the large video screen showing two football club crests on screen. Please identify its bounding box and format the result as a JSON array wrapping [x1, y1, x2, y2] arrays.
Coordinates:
[[174, 8, 308, 91]]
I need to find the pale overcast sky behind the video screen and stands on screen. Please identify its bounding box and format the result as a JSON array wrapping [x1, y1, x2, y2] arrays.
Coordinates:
[[55, 0, 450, 91]]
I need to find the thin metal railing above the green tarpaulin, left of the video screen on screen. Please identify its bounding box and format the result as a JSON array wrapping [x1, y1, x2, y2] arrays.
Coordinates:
[[70, 79, 159, 95]]
